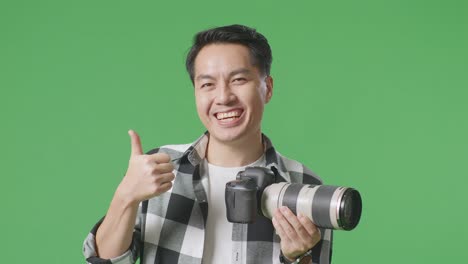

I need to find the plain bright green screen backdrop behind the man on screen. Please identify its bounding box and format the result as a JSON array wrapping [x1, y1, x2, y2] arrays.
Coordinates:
[[0, 0, 468, 263]]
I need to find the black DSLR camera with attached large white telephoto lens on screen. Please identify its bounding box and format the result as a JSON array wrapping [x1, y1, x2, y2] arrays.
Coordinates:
[[225, 167, 362, 230]]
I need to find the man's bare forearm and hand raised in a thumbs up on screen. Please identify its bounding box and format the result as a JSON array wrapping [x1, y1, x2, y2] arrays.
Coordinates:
[[96, 130, 174, 259]]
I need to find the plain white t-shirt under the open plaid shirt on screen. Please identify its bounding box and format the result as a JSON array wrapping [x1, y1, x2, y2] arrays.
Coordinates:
[[201, 155, 265, 264]]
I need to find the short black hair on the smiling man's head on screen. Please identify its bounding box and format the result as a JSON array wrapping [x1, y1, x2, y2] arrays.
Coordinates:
[[185, 25, 272, 83]]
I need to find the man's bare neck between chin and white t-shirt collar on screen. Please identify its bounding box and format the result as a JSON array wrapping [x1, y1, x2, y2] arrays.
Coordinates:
[[206, 131, 264, 167]]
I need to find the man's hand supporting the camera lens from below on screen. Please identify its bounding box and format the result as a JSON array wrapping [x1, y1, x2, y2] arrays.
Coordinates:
[[272, 206, 321, 260]]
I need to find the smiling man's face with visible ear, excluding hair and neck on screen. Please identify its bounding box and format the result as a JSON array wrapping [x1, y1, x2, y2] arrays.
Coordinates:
[[194, 44, 273, 143]]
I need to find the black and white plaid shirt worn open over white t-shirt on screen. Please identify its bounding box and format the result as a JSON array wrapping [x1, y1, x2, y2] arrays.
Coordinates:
[[83, 132, 333, 264]]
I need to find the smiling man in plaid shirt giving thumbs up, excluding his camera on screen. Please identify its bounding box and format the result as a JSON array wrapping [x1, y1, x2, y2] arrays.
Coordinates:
[[84, 25, 332, 264]]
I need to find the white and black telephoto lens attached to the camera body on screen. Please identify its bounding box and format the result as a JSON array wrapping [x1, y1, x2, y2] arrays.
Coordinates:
[[261, 182, 362, 230]]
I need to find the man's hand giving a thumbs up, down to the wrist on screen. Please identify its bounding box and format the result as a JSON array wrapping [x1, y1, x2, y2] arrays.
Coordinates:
[[117, 130, 175, 204]]
